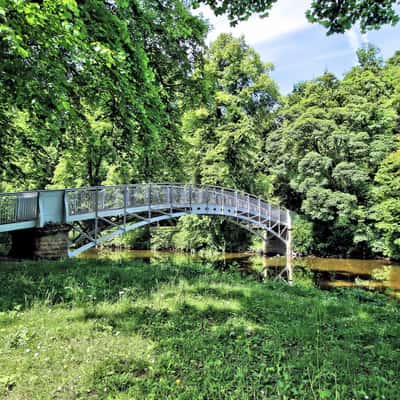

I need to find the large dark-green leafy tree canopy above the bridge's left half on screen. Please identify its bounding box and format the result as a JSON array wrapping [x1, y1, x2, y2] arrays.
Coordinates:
[[0, 0, 207, 189]]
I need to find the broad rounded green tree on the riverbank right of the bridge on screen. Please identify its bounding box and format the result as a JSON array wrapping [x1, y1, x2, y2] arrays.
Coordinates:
[[266, 47, 399, 255]]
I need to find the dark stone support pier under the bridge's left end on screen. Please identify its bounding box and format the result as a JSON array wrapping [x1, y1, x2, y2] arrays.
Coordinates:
[[9, 224, 71, 260]]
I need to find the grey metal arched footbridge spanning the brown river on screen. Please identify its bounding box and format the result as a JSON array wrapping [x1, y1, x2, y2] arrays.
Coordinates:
[[0, 183, 291, 282]]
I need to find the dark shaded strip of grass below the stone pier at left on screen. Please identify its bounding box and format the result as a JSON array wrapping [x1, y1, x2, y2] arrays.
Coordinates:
[[0, 259, 210, 311]]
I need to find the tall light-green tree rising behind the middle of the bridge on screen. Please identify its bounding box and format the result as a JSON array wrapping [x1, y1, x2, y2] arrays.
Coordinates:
[[167, 34, 279, 249]]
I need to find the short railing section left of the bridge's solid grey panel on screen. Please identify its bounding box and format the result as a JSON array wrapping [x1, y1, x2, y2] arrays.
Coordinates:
[[0, 192, 38, 225]]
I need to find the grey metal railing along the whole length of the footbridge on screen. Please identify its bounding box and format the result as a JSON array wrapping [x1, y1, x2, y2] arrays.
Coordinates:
[[0, 182, 287, 225]]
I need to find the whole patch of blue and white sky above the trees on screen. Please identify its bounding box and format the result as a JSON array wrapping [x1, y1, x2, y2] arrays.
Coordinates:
[[196, 0, 400, 93]]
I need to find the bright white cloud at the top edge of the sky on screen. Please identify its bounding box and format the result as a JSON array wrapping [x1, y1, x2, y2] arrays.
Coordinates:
[[196, 0, 311, 45]]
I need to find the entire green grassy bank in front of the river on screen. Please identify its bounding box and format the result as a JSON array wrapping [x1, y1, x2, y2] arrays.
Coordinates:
[[0, 260, 400, 400]]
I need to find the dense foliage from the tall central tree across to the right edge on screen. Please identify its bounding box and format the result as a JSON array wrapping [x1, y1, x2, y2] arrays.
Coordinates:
[[155, 42, 400, 257]]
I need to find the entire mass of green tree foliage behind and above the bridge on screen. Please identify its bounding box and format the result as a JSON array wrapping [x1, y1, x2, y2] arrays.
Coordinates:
[[0, 0, 400, 258]]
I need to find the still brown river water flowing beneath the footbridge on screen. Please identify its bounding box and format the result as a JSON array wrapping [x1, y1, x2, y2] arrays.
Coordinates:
[[82, 249, 400, 299]]
